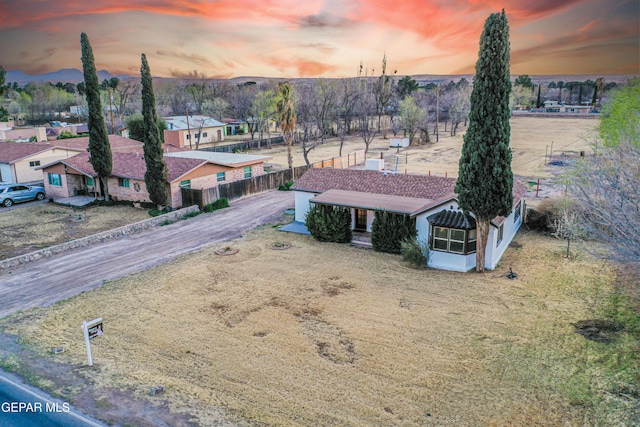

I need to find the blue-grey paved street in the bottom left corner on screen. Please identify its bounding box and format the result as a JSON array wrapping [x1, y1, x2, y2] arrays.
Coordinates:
[[0, 370, 105, 427]]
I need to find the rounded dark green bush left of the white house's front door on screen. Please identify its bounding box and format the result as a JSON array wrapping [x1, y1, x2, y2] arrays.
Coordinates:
[[305, 205, 352, 243]]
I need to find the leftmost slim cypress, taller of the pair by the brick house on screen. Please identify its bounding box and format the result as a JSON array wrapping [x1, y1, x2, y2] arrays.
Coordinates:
[[80, 33, 113, 201]]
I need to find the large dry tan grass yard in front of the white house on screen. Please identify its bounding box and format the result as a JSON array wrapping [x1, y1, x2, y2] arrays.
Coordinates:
[[0, 227, 633, 426]]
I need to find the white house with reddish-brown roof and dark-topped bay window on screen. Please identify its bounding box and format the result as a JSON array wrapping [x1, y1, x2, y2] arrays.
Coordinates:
[[292, 169, 527, 271]]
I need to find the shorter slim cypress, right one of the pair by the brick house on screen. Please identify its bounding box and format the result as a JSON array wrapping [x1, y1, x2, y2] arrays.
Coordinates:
[[140, 53, 169, 206]]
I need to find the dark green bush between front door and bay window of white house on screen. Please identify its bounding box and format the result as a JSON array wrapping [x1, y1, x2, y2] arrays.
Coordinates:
[[371, 211, 417, 254]]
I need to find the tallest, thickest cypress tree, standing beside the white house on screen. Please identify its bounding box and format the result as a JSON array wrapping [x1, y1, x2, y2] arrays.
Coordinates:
[[455, 9, 513, 271]]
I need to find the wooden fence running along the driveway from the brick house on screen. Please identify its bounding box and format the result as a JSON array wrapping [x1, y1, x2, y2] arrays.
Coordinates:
[[182, 151, 365, 209]]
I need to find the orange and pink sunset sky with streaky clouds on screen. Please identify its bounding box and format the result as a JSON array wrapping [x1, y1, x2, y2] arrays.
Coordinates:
[[0, 0, 640, 78]]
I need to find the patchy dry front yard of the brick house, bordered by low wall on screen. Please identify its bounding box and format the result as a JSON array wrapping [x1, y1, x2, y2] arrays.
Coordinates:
[[0, 203, 151, 259]]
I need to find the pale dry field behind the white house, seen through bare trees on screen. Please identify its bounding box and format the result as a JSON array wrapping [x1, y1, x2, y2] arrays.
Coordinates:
[[231, 117, 599, 178]]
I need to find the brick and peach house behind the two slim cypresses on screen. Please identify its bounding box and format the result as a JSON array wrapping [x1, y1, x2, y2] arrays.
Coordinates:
[[41, 150, 271, 208]]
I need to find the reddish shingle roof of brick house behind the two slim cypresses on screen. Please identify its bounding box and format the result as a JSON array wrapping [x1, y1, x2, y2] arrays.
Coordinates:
[[45, 152, 207, 182]]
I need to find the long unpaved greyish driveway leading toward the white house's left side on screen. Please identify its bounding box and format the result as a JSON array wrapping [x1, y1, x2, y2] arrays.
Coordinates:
[[0, 191, 294, 318]]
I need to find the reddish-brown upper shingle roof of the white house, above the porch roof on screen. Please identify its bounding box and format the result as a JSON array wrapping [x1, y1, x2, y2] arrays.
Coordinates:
[[293, 168, 456, 200]]
